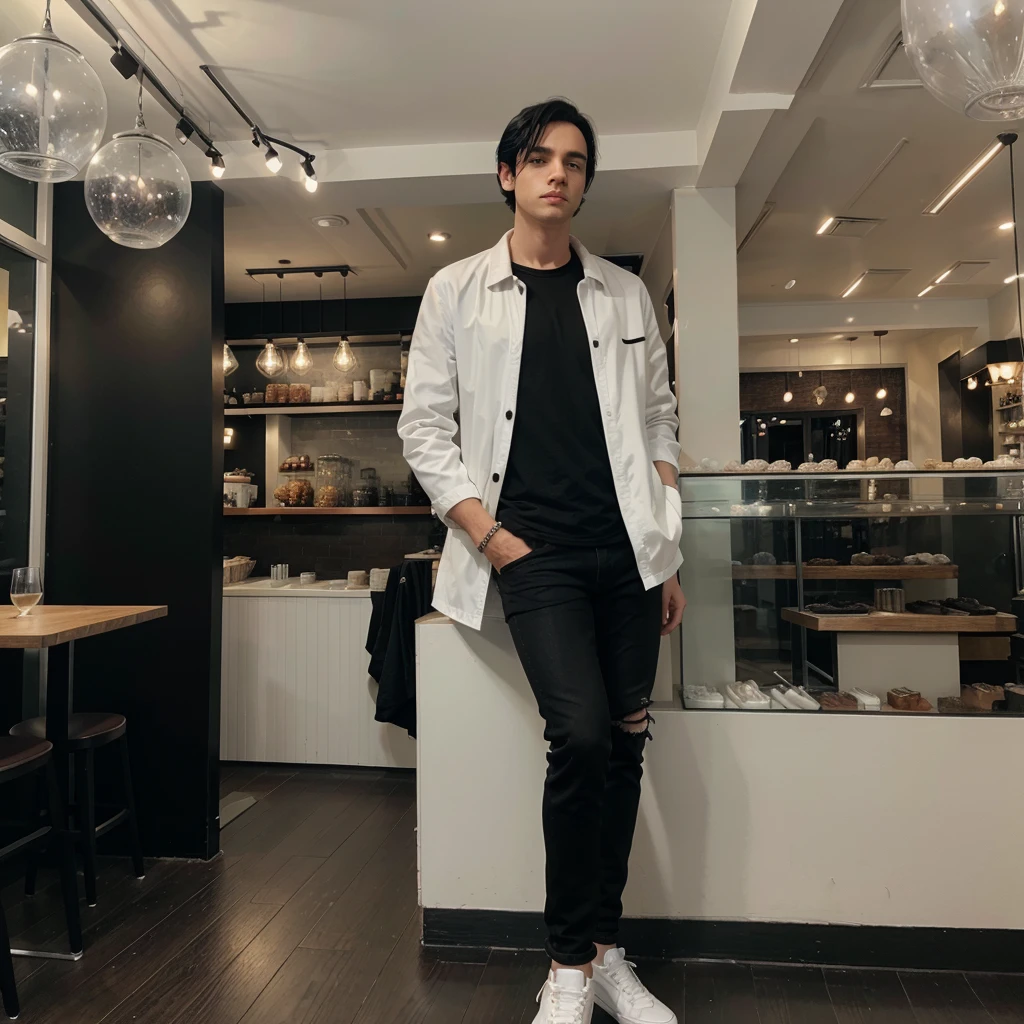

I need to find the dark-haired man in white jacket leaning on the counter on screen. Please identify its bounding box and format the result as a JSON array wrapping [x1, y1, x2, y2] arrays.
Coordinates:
[[398, 99, 686, 1024]]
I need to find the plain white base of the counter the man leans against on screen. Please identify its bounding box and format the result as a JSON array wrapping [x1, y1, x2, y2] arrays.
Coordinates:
[[417, 615, 1024, 928]]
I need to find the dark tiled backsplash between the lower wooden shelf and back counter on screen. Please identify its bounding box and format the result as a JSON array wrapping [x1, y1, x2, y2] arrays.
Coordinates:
[[224, 515, 446, 580]]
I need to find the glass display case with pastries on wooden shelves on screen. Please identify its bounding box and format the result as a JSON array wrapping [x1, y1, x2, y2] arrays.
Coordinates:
[[679, 470, 1024, 714]]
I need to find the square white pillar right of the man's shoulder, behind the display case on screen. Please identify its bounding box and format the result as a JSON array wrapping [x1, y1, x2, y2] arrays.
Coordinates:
[[672, 188, 739, 686]]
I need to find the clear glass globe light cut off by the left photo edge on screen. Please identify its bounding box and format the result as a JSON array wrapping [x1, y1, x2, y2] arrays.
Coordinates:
[[0, 0, 106, 182]]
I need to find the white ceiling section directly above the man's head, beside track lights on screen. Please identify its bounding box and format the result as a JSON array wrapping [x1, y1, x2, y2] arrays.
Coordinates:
[[112, 0, 729, 147]]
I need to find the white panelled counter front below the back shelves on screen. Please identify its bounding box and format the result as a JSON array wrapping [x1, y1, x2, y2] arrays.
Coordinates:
[[220, 579, 416, 768]]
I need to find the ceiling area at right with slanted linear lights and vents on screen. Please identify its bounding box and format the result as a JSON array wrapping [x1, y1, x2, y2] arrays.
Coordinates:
[[737, 0, 1024, 303]]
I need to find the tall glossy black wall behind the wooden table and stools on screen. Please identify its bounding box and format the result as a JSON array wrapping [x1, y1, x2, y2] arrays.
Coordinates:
[[46, 182, 224, 857]]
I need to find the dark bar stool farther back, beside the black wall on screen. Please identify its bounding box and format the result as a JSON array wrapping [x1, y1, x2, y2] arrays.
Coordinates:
[[10, 712, 145, 906]]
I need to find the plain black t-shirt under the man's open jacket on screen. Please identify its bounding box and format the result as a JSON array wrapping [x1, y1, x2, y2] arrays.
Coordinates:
[[497, 250, 628, 547]]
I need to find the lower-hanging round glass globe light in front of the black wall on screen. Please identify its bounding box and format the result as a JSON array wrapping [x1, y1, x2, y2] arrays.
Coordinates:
[[85, 72, 191, 249]]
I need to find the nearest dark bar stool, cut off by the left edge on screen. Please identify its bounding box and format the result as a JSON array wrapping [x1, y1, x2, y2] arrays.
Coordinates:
[[0, 736, 82, 1017]]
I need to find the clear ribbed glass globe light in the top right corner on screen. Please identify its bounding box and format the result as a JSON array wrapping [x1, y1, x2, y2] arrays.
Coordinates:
[[902, 0, 1024, 121]]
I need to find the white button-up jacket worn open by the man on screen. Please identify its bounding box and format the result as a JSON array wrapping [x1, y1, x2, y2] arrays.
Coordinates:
[[398, 232, 683, 630]]
